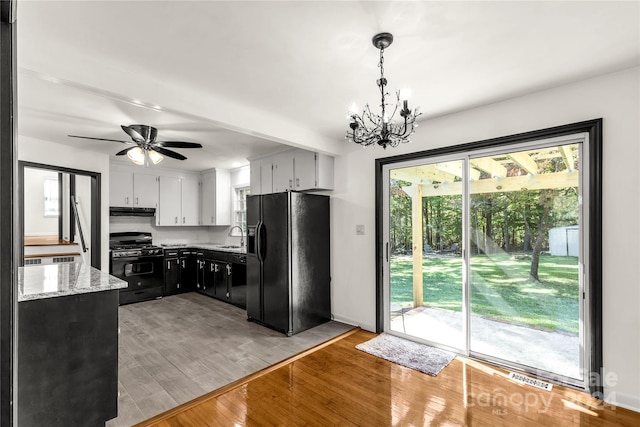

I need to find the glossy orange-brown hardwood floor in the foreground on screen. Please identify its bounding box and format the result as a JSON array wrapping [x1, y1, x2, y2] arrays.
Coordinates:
[[132, 329, 640, 427]]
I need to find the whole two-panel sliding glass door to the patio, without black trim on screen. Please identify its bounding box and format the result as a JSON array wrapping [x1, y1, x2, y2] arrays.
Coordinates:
[[383, 134, 589, 387]]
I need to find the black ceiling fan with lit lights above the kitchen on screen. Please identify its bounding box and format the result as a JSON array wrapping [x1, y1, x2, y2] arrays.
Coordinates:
[[68, 125, 202, 165]]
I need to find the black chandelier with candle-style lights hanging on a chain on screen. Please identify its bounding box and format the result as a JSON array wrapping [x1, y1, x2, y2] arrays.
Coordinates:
[[345, 33, 422, 148]]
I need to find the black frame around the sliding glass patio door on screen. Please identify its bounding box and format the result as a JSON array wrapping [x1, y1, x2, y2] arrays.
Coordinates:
[[375, 119, 603, 398]]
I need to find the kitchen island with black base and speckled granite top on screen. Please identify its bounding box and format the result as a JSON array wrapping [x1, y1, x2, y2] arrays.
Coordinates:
[[18, 263, 127, 427]]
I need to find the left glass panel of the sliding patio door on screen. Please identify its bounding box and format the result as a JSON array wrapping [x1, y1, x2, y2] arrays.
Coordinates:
[[388, 158, 466, 351]]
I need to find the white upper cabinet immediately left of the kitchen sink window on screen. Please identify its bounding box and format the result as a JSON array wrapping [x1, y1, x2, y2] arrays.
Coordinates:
[[200, 169, 231, 225]]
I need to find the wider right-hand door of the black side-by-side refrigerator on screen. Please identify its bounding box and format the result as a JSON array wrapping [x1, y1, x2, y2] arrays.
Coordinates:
[[260, 193, 291, 333]]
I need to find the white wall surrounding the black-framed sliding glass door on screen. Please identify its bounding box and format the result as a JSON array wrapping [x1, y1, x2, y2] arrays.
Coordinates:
[[331, 68, 640, 410]]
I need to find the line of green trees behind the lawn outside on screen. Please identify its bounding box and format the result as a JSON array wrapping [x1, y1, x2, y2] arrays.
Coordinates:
[[389, 180, 579, 280]]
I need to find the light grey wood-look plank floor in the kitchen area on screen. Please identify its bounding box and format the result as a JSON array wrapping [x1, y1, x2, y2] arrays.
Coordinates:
[[106, 293, 353, 427]]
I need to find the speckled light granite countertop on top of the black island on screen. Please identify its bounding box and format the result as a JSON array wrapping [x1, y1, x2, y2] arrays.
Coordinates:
[[18, 263, 127, 302]]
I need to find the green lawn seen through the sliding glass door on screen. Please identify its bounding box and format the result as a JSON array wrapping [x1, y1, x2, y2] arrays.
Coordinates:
[[391, 254, 579, 334]]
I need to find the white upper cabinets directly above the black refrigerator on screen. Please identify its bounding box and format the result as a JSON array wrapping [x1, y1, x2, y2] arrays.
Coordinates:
[[251, 149, 334, 194]]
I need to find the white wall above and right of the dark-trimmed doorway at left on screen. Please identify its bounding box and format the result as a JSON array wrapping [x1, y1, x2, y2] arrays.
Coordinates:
[[18, 136, 109, 272]]
